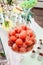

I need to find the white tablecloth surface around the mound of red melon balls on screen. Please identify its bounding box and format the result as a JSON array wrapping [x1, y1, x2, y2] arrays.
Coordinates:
[[0, 18, 43, 65]]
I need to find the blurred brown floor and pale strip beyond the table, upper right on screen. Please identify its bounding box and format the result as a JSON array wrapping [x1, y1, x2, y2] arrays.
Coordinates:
[[32, 0, 43, 27]]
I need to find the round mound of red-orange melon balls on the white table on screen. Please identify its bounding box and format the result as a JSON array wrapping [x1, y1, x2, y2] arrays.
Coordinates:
[[8, 25, 36, 53]]
